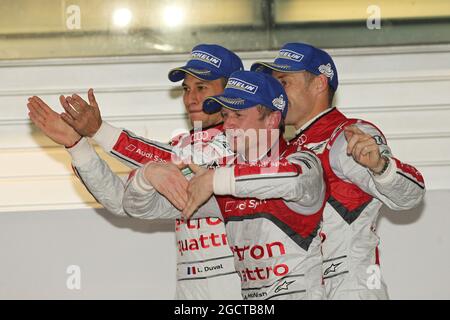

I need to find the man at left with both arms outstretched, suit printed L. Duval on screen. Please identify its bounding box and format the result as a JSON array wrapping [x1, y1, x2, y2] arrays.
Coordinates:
[[28, 44, 243, 299]]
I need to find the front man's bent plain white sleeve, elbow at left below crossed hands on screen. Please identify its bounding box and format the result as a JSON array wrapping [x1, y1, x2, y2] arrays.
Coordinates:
[[123, 168, 222, 219]]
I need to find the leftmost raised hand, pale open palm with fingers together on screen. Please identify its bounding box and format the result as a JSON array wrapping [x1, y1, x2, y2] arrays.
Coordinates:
[[27, 96, 81, 147]]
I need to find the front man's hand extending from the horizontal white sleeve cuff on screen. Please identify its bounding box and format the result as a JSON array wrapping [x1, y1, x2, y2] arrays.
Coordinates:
[[183, 164, 214, 218]]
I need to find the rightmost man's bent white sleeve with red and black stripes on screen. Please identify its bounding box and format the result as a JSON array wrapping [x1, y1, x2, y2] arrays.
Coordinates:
[[329, 124, 425, 210]]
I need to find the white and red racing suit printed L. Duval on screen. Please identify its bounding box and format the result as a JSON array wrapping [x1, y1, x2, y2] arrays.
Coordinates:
[[69, 122, 242, 300]]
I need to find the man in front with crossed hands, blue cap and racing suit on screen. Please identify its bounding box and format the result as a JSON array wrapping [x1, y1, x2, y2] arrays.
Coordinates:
[[123, 71, 326, 299]]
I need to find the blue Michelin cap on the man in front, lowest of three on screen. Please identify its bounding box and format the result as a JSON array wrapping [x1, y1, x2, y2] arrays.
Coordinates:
[[203, 71, 288, 118]]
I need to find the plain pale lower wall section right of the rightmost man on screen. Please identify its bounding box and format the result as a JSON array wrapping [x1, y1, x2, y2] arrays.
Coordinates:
[[378, 190, 450, 300]]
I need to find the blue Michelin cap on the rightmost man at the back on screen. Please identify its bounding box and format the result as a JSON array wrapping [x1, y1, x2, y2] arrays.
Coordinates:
[[250, 43, 338, 91]]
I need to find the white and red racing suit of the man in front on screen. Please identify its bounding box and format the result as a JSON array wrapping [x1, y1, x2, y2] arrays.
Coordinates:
[[123, 139, 326, 299]]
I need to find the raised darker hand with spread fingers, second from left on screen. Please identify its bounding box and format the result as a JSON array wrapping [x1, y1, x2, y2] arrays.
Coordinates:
[[59, 89, 102, 138]]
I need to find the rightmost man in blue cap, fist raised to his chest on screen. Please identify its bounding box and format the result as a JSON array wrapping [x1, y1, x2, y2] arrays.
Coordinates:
[[251, 43, 425, 299]]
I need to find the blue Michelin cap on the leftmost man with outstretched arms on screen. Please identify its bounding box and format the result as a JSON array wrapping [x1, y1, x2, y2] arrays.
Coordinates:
[[169, 44, 244, 82]]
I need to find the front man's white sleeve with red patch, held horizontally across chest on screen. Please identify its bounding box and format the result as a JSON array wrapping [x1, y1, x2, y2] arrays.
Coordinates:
[[213, 151, 325, 214]]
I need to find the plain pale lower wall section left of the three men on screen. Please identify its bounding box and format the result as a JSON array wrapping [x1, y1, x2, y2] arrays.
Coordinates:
[[0, 209, 176, 299]]
